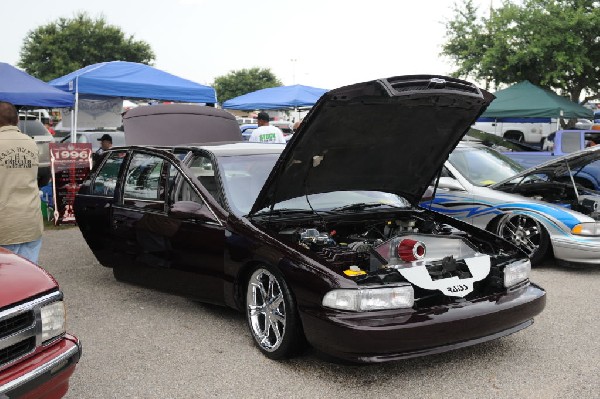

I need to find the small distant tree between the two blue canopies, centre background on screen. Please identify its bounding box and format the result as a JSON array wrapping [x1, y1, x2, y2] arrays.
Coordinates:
[[213, 68, 281, 103]]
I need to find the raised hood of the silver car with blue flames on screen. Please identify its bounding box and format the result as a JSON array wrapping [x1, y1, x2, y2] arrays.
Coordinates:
[[489, 146, 600, 188]]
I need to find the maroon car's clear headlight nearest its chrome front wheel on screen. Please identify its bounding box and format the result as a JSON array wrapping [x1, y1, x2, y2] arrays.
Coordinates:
[[323, 285, 415, 312]]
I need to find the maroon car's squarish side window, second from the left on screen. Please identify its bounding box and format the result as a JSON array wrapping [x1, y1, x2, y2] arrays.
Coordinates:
[[123, 154, 165, 201]]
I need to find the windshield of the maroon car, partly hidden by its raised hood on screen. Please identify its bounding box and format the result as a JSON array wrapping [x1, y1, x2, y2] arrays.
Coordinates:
[[219, 154, 410, 215]]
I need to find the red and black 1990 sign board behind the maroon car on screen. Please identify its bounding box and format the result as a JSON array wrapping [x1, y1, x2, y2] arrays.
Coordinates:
[[50, 143, 92, 225]]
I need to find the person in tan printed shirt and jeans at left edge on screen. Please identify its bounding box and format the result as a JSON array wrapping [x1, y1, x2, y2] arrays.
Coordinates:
[[0, 101, 44, 263]]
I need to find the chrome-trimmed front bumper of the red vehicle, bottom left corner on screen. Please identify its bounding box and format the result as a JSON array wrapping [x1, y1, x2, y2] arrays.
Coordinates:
[[0, 334, 81, 399]]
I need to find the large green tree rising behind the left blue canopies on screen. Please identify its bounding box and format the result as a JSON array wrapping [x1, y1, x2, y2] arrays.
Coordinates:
[[18, 13, 154, 81]]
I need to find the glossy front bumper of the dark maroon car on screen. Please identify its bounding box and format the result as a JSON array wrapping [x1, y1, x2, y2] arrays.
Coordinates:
[[301, 284, 546, 362]]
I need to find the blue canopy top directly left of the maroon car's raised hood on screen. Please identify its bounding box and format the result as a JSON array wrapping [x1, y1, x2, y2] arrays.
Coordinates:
[[223, 85, 327, 110]]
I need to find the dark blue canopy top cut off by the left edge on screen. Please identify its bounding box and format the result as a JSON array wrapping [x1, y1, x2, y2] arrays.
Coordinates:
[[0, 62, 75, 108]]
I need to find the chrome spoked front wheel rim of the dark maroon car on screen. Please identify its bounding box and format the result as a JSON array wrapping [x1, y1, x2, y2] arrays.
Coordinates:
[[246, 268, 286, 352]]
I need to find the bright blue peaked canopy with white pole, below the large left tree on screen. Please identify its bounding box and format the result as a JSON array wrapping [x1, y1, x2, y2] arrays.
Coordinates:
[[49, 61, 217, 138]]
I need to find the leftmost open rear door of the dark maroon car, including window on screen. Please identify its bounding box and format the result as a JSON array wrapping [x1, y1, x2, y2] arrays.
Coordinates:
[[74, 151, 127, 267]]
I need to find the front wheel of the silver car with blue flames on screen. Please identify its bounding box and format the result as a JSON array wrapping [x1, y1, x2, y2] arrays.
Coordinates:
[[493, 213, 550, 266]]
